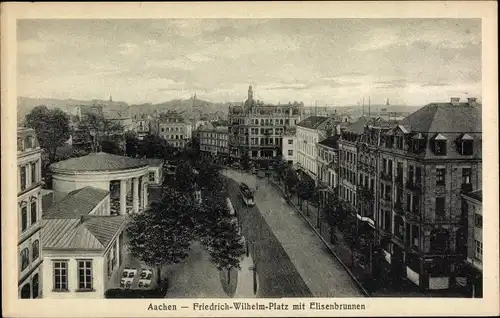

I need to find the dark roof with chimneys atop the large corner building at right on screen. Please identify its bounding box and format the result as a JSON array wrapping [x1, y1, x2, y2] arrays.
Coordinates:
[[400, 103, 482, 133]]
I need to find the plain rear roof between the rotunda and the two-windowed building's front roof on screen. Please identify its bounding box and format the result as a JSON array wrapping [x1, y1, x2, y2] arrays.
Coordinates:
[[43, 187, 109, 219]]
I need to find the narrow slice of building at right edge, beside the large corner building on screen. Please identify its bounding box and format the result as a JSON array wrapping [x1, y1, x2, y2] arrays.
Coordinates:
[[462, 190, 483, 298]]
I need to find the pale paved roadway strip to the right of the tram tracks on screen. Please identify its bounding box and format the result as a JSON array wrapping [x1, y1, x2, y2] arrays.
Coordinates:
[[224, 170, 364, 297]]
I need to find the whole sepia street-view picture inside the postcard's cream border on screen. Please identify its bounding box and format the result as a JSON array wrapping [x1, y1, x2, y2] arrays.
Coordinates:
[[2, 1, 498, 315]]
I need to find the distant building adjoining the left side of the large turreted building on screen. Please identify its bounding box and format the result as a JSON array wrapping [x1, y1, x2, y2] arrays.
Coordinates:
[[198, 123, 229, 162]]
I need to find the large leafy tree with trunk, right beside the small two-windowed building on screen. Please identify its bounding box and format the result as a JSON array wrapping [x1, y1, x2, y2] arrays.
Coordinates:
[[127, 189, 197, 283]]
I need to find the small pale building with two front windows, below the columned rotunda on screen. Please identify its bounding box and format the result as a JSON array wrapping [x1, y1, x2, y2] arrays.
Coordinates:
[[42, 186, 128, 298]]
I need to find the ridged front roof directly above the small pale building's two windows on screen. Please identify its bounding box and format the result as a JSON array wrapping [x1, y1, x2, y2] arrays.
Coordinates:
[[42, 215, 127, 251]]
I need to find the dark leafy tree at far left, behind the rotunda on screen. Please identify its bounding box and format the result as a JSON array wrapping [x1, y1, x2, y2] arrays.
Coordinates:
[[26, 105, 70, 162]]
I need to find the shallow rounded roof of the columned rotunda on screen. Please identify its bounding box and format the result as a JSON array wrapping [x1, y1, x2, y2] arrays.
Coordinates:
[[50, 152, 148, 171]]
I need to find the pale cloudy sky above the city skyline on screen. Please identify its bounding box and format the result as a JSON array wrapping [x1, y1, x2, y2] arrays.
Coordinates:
[[17, 19, 481, 106]]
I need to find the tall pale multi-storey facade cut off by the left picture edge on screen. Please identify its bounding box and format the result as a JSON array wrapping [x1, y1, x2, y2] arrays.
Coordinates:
[[17, 128, 43, 298]]
